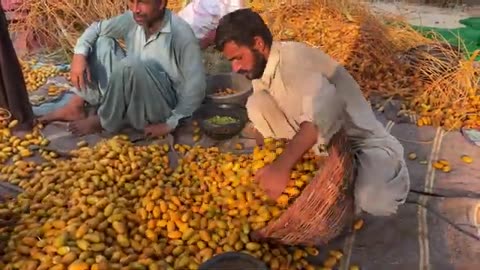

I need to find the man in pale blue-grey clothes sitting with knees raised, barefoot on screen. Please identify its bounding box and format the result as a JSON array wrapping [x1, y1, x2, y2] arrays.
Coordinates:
[[39, 0, 206, 136]]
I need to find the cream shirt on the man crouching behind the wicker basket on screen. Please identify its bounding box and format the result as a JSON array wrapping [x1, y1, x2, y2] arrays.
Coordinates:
[[252, 42, 403, 153]]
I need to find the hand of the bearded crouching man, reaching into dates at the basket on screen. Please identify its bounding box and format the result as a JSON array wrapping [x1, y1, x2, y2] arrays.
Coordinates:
[[255, 162, 290, 200]]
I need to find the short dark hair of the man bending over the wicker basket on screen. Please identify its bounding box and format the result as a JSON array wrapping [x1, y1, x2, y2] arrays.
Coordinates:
[[215, 8, 273, 51]]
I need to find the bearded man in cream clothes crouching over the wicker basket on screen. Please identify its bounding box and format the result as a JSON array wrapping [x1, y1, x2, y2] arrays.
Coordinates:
[[215, 9, 410, 216]]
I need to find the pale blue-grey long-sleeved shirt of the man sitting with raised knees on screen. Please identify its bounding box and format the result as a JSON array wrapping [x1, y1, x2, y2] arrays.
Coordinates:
[[74, 10, 206, 128]]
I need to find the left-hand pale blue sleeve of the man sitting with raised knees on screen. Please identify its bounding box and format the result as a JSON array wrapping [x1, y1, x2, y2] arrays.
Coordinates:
[[74, 11, 136, 55]]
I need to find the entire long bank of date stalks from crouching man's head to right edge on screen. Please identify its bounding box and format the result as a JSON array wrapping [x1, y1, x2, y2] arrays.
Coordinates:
[[252, 0, 480, 129]]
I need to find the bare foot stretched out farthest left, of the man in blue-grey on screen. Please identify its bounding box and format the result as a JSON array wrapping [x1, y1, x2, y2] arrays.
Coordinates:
[[37, 96, 86, 124]]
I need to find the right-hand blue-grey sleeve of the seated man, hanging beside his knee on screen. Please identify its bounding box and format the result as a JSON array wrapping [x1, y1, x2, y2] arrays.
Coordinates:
[[167, 41, 207, 129]]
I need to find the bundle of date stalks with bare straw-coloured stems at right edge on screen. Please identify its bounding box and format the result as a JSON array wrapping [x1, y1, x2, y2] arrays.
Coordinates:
[[388, 21, 480, 130]]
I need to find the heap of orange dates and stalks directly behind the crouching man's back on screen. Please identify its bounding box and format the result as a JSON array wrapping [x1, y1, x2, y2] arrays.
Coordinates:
[[256, 0, 418, 98]]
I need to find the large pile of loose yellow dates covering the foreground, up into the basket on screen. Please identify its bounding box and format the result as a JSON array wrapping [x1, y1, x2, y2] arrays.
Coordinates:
[[0, 130, 364, 270]]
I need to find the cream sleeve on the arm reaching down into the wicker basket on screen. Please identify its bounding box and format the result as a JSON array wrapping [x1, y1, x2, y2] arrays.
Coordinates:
[[298, 75, 345, 150]]
